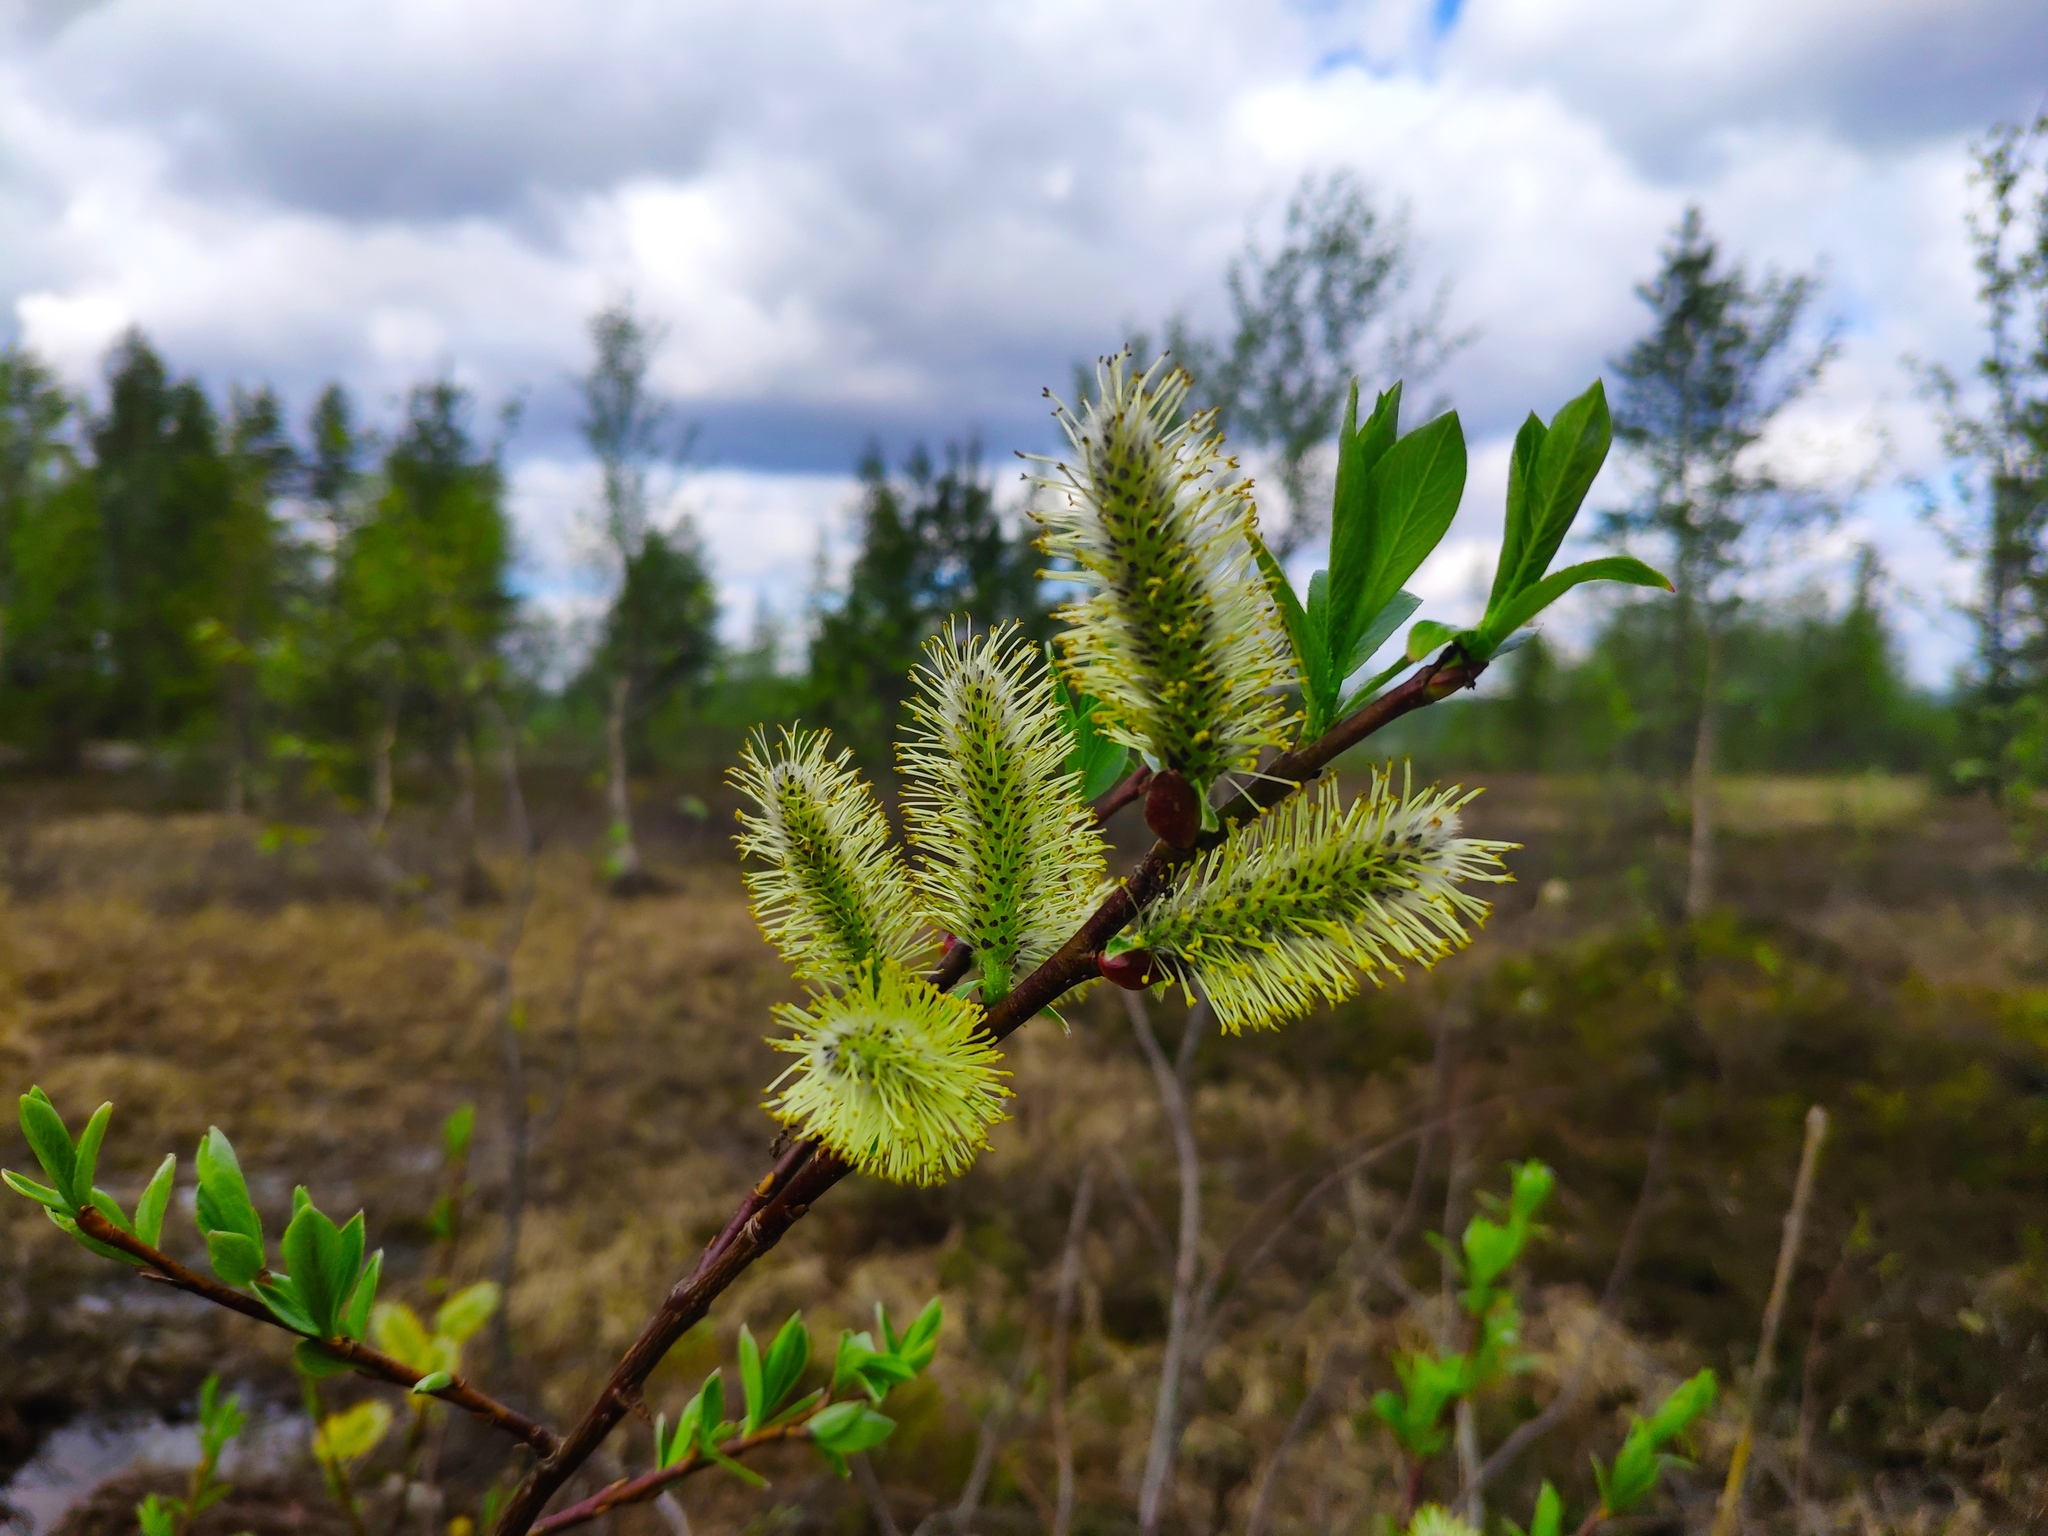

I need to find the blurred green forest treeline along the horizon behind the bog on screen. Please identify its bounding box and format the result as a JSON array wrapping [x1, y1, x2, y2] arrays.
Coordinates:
[[0, 119, 2048, 843]]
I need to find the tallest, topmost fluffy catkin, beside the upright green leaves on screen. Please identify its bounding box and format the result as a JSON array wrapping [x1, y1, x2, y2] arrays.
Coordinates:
[[1036, 352, 1294, 788]]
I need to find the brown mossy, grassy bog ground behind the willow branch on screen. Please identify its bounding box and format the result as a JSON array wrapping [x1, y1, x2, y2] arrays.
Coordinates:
[[0, 778, 2048, 1536]]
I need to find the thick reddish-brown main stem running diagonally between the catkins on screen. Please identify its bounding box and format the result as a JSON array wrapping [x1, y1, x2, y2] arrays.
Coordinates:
[[494, 647, 1485, 1536]]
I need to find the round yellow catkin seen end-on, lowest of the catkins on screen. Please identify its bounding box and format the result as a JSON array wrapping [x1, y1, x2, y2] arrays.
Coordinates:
[[768, 965, 1010, 1184]]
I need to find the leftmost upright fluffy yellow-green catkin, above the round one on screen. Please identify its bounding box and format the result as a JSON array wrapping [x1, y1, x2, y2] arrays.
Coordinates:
[[731, 731, 926, 983]]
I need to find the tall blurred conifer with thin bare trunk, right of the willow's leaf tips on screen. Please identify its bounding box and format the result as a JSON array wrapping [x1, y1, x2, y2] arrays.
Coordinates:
[[1606, 207, 1835, 915]]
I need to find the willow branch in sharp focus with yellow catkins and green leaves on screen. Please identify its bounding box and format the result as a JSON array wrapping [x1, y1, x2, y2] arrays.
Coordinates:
[[8, 354, 1669, 1536]]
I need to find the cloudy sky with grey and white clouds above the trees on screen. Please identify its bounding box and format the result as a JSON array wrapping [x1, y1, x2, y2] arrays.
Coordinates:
[[0, 0, 2048, 676]]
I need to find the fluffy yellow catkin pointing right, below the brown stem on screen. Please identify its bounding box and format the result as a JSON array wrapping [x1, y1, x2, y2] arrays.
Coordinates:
[[1135, 772, 1513, 1034]]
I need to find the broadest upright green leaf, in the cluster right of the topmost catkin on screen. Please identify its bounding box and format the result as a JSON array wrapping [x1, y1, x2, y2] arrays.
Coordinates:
[[1329, 412, 1466, 659]]
